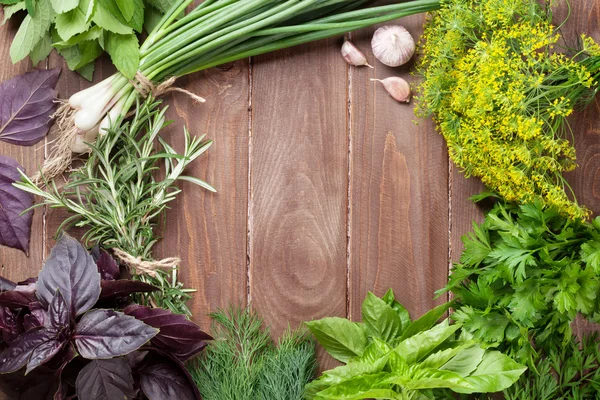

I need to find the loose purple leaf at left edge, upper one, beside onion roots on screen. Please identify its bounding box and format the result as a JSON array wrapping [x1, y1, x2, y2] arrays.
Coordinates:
[[0, 68, 60, 146]]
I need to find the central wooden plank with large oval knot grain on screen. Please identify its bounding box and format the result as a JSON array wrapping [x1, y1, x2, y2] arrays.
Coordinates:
[[249, 40, 348, 368]]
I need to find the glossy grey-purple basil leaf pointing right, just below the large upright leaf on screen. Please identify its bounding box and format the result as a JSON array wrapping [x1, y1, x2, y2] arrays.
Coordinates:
[[75, 310, 158, 360]]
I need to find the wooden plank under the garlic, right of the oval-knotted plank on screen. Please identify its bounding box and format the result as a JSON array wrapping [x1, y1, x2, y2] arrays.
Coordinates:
[[349, 16, 448, 320]]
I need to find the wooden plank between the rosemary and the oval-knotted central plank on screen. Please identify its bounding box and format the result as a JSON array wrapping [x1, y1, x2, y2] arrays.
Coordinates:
[[155, 61, 249, 328]]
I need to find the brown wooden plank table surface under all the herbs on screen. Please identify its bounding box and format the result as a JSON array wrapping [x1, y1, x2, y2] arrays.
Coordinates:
[[0, 0, 600, 376]]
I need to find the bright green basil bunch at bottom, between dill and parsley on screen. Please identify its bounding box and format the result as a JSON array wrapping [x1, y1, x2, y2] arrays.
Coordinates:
[[305, 289, 526, 400]]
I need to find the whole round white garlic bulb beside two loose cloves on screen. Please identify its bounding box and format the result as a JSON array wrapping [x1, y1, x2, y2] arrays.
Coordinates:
[[371, 25, 415, 67]]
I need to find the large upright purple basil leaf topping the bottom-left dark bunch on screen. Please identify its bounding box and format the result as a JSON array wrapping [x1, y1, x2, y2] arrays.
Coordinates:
[[36, 234, 100, 318]]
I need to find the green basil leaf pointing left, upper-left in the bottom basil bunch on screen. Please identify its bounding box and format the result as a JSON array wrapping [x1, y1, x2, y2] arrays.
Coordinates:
[[306, 317, 368, 362]]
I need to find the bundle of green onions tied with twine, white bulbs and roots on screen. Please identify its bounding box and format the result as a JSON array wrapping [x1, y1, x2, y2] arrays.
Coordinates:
[[41, 0, 440, 179]]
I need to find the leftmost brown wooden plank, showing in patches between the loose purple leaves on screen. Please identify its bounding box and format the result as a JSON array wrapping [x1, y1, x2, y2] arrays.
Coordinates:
[[0, 12, 46, 281]]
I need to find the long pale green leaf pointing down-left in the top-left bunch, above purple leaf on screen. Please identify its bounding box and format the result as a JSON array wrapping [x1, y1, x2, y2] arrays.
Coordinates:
[[10, 0, 54, 63]]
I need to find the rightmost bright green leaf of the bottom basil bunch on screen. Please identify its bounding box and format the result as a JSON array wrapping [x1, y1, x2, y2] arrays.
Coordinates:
[[455, 351, 527, 393]]
